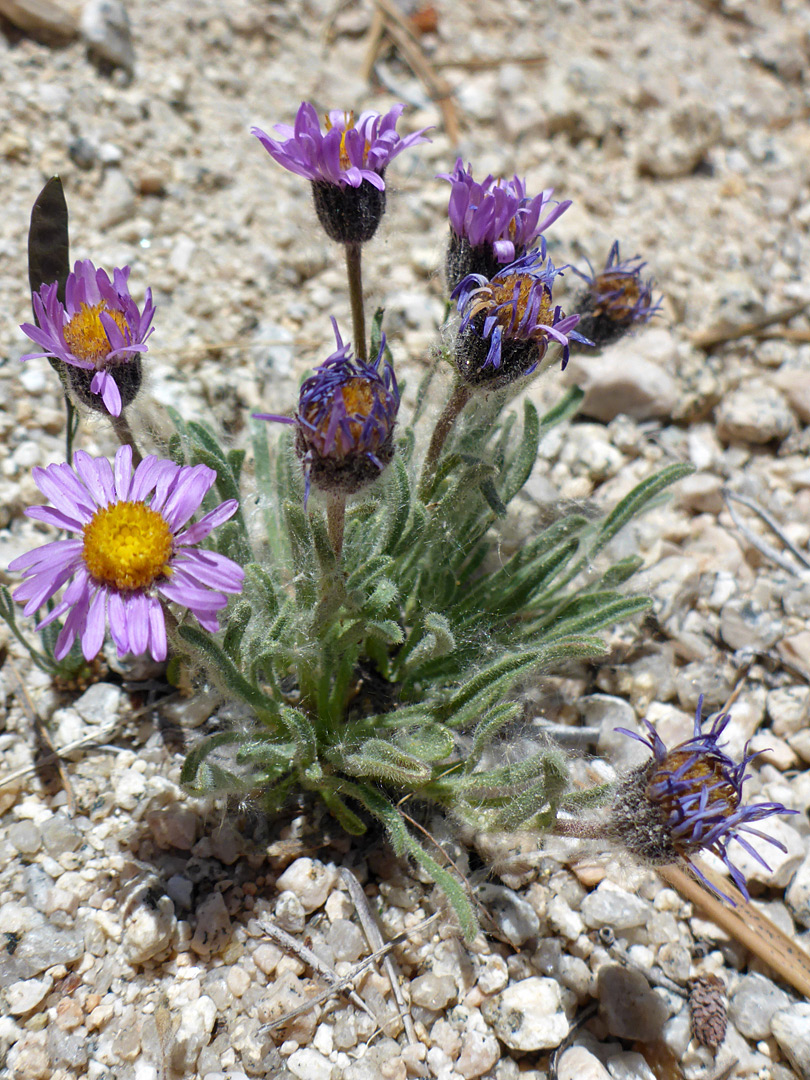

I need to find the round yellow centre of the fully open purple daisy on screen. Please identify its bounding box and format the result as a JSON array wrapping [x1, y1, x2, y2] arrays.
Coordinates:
[[82, 502, 173, 591]]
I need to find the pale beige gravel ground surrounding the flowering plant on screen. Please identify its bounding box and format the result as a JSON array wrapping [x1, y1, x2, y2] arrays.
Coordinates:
[[0, 0, 810, 1080]]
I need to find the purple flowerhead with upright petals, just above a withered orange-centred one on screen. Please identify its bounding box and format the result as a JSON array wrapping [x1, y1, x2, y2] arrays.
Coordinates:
[[438, 158, 571, 291]]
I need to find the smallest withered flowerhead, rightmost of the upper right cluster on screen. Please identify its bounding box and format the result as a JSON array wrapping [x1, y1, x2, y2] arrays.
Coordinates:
[[571, 240, 661, 347]]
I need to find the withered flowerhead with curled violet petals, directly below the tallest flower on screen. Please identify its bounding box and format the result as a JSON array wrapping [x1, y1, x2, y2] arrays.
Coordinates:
[[253, 319, 400, 505]]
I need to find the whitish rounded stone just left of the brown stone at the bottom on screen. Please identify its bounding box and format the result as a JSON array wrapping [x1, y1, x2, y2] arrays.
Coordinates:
[[481, 976, 570, 1050]]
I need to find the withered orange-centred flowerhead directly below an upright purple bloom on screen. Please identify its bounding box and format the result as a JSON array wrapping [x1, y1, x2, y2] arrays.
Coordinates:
[[453, 247, 588, 390]]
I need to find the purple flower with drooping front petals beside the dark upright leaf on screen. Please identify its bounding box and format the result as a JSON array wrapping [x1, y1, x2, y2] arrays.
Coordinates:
[[21, 259, 154, 416]]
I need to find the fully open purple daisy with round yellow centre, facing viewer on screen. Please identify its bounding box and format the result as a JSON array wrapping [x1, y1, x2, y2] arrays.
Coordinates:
[[9, 446, 244, 660]]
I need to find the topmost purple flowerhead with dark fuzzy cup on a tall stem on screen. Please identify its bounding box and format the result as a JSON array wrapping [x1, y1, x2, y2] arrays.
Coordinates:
[[251, 102, 428, 244]]
